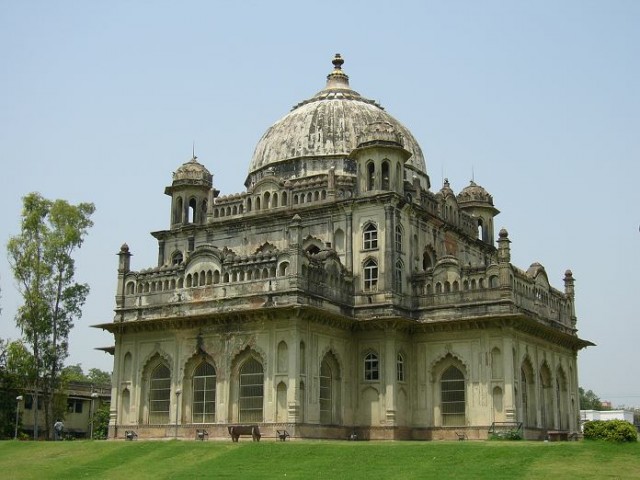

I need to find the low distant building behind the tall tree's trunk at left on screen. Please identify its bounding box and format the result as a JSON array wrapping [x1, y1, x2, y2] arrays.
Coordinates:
[[19, 382, 111, 438]]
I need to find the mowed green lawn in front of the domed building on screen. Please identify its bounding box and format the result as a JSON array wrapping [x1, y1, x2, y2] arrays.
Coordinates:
[[0, 439, 640, 480]]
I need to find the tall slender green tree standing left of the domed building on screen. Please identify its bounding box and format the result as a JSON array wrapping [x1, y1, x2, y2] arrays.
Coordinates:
[[7, 193, 95, 438]]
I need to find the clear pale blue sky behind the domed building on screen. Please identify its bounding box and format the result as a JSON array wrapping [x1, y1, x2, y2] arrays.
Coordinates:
[[0, 0, 640, 406]]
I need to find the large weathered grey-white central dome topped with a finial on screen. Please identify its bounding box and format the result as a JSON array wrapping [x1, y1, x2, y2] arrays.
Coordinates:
[[249, 54, 427, 184]]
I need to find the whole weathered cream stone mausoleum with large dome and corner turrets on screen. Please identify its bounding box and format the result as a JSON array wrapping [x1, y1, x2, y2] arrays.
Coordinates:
[[99, 55, 591, 439]]
